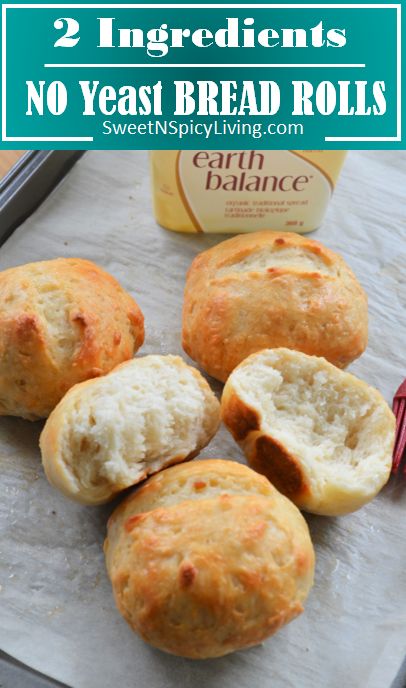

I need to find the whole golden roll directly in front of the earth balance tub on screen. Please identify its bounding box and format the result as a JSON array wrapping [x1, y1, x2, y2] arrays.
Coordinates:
[[183, 232, 368, 381]]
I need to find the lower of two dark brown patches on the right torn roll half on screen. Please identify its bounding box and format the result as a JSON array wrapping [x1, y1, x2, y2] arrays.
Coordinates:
[[247, 435, 310, 502]]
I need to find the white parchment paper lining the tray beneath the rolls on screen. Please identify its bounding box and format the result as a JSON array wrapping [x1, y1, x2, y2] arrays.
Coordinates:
[[0, 151, 406, 688]]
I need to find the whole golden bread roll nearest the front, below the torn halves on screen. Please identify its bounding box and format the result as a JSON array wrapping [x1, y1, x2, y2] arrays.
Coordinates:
[[105, 459, 314, 659]]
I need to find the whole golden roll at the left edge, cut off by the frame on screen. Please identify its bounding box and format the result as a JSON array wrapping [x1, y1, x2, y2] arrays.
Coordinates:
[[0, 258, 144, 420]]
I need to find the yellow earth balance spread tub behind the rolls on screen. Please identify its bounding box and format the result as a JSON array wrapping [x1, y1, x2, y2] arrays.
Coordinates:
[[151, 150, 346, 234]]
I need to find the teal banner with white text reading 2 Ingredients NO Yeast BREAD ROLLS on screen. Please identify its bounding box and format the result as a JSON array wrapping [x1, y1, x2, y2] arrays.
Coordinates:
[[1, 2, 404, 150]]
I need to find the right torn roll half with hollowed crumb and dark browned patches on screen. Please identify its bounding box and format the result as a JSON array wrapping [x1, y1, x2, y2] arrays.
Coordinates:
[[221, 349, 395, 516]]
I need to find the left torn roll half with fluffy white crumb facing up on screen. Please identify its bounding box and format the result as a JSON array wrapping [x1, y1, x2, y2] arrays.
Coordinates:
[[40, 356, 220, 504]]
